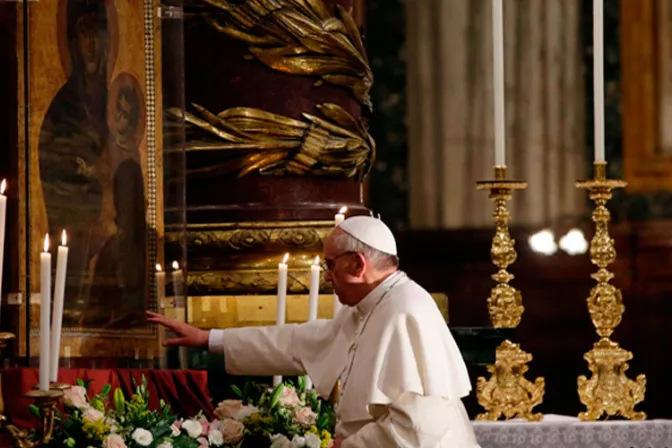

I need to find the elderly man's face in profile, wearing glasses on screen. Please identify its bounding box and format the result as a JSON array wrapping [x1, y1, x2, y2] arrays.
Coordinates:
[[324, 229, 363, 305]]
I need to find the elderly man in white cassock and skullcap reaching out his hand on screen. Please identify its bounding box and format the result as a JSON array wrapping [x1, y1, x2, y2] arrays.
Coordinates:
[[148, 216, 478, 448]]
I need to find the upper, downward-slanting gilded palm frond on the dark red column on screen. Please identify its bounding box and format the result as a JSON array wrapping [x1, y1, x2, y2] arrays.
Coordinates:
[[204, 0, 373, 108]]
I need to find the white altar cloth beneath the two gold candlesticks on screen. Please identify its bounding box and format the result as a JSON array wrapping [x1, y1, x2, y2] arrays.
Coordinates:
[[473, 414, 672, 448]]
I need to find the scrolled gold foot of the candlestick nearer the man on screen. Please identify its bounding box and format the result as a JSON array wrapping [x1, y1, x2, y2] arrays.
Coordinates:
[[476, 341, 546, 422]]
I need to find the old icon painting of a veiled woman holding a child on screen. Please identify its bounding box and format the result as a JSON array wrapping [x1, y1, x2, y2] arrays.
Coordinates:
[[13, 0, 163, 356]]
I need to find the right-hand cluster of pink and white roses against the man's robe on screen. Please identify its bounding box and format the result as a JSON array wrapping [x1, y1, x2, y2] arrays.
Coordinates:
[[215, 377, 335, 448]]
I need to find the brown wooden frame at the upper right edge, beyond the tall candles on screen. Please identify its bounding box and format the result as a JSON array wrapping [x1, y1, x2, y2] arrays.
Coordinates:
[[620, 0, 672, 193]]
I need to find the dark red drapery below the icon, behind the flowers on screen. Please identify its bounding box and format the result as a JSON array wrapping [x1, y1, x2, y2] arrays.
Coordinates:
[[2, 368, 214, 428]]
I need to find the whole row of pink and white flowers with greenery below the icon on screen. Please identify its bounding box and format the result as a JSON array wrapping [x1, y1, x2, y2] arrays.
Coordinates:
[[30, 377, 335, 448]]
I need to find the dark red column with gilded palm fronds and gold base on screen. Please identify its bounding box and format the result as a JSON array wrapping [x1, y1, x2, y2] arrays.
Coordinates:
[[167, 0, 374, 326]]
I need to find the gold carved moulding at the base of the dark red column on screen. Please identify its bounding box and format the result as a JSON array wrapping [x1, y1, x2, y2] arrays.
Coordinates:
[[166, 221, 334, 296]]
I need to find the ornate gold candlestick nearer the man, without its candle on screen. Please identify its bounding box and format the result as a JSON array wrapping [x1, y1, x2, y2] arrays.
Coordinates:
[[476, 166, 546, 421]]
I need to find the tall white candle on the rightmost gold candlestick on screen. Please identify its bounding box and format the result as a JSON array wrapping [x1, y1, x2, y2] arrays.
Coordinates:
[[593, 0, 604, 162]]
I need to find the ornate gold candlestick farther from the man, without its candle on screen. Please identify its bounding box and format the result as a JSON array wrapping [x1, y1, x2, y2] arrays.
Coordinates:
[[576, 162, 646, 421]]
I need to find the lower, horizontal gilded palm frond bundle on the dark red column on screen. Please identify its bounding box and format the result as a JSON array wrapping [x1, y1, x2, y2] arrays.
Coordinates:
[[168, 104, 375, 180]]
